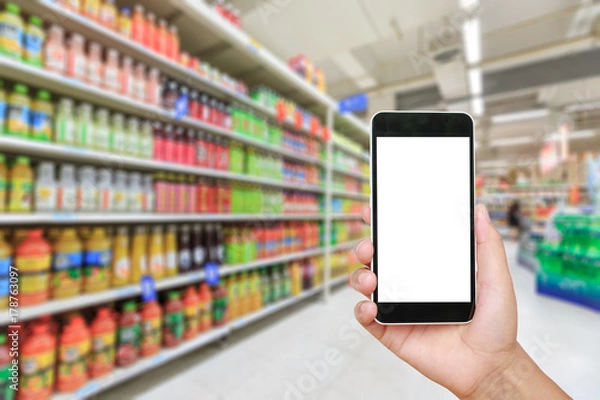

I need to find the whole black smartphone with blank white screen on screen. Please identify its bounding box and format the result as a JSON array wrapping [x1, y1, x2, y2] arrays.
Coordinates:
[[371, 111, 476, 324]]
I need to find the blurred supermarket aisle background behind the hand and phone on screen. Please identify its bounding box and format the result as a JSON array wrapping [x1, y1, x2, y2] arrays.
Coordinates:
[[0, 0, 600, 400]]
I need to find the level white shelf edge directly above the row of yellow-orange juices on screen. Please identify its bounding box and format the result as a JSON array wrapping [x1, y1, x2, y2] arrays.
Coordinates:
[[0, 212, 324, 226]]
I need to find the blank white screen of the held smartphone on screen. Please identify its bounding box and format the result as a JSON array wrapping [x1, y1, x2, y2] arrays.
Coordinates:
[[376, 137, 471, 303]]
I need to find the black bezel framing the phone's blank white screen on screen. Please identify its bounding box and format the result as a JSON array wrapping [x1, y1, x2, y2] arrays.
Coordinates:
[[371, 111, 476, 325]]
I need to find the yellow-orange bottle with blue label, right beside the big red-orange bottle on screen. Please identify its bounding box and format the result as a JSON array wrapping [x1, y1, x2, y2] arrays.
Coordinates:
[[50, 228, 83, 299]]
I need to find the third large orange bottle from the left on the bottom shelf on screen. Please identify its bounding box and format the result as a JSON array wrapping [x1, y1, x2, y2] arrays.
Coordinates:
[[88, 308, 117, 378]]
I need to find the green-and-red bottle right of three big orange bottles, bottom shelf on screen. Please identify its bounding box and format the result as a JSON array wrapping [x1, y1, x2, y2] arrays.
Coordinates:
[[116, 301, 141, 367]]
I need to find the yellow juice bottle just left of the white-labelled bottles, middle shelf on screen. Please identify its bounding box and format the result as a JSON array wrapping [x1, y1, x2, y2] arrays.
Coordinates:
[[8, 156, 33, 212]]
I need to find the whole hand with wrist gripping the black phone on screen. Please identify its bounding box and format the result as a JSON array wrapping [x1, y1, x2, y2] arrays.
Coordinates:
[[351, 205, 569, 399]]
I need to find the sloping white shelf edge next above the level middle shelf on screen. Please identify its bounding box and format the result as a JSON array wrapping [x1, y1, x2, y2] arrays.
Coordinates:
[[0, 136, 324, 193]]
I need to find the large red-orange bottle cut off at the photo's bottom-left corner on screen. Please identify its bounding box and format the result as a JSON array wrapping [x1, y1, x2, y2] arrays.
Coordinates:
[[19, 321, 56, 400]]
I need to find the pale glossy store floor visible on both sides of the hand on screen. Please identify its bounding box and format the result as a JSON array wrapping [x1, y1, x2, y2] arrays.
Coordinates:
[[103, 243, 600, 400]]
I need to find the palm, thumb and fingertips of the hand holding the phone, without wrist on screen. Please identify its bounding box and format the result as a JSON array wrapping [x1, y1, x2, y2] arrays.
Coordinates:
[[358, 206, 517, 396]]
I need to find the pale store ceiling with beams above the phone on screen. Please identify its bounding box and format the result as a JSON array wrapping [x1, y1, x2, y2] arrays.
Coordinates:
[[227, 0, 600, 177]]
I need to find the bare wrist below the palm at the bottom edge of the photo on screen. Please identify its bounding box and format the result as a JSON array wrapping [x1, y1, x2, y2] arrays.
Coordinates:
[[466, 345, 570, 400]]
